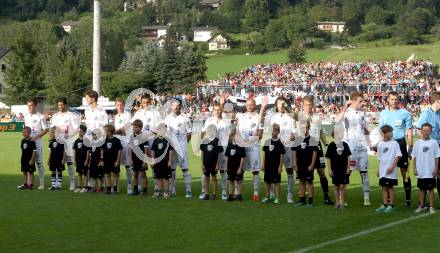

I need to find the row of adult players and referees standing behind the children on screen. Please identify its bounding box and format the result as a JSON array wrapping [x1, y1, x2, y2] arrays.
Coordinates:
[[21, 91, 440, 209]]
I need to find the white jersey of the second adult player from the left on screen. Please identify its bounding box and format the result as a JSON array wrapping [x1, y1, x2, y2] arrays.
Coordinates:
[[50, 111, 80, 156]]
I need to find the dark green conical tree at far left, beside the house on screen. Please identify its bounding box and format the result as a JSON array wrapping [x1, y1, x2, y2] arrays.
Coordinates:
[[5, 34, 45, 104]]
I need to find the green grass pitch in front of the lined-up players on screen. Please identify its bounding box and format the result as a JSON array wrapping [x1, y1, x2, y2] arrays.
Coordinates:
[[0, 133, 440, 253]]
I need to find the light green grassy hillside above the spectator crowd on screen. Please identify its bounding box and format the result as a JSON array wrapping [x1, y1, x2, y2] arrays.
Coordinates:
[[207, 43, 440, 80]]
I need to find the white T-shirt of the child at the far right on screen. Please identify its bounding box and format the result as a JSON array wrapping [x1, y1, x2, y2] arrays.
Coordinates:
[[412, 139, 440, 178]]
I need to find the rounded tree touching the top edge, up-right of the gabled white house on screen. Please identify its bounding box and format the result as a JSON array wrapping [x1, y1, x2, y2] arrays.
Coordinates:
[[244, 0, 270, 31]]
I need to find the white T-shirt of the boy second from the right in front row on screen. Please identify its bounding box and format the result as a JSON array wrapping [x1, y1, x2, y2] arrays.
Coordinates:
[[377, 140, 402, 179]]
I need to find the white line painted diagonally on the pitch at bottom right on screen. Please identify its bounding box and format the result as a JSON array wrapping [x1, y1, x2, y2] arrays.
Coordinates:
[[292, 213, 431, 253]]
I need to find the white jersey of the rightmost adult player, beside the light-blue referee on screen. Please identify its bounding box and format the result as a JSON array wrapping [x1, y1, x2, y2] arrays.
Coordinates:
[[343, 108, 368, 150]]
